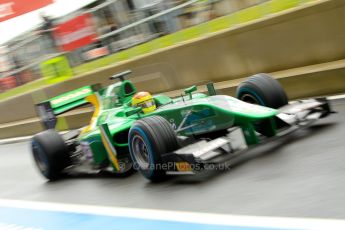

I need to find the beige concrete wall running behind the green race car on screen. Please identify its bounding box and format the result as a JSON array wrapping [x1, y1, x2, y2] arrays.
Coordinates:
[[0, 0, 345, 138]]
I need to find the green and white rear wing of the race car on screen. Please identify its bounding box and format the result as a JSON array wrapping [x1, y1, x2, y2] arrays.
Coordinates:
[[35, 84, 101, 129]]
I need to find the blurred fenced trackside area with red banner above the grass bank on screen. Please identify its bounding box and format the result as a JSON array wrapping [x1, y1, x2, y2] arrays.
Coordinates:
[[0, 0, 267, 92]]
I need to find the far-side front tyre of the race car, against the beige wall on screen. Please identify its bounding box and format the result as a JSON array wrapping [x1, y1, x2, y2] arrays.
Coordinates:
[[236, 73, 288, 109]]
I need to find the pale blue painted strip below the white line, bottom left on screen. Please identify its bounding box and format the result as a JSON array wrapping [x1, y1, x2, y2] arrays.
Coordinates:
[[0, 207, 284, 230]]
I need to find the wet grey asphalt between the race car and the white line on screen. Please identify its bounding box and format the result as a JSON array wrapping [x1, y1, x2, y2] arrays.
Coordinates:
[[0, 100, 345, 218]]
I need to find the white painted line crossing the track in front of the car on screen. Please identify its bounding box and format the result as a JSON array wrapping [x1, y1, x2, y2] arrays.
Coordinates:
[[0, 199, 345, 230]]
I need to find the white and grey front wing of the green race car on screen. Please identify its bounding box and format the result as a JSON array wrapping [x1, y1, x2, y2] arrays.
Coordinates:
[[162, 98, 334, 175]]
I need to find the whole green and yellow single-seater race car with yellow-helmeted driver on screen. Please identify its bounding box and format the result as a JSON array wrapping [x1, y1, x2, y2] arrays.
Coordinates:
[[32, 71, 332, 181]]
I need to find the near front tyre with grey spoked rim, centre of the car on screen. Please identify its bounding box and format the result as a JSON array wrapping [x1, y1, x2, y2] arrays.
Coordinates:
[[128, 116, 178, 182]]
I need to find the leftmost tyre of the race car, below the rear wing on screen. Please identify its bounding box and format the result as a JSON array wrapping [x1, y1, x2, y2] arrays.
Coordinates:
[[31, 129, 71, 181]]
